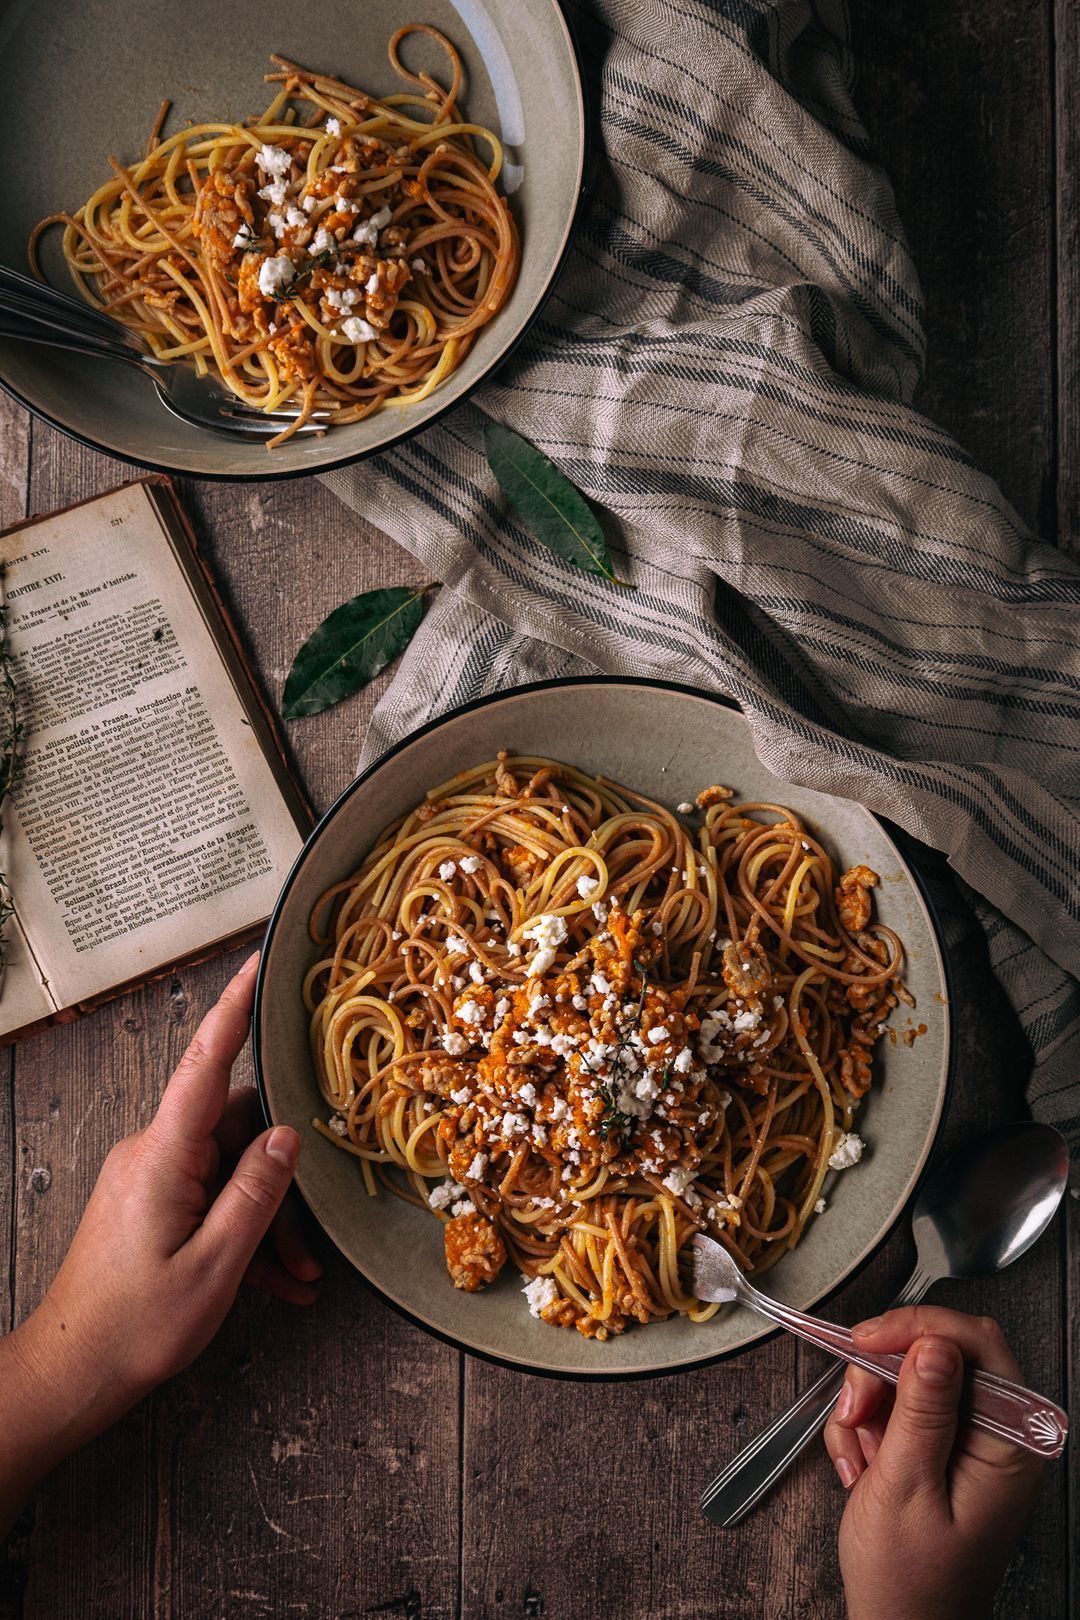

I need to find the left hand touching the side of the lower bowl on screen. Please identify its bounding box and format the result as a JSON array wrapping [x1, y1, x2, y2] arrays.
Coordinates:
[[13, 953, 321, 1443]]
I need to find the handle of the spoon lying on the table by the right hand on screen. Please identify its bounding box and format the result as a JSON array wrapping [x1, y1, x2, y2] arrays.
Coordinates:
[[701, 1267, 936, 1529]]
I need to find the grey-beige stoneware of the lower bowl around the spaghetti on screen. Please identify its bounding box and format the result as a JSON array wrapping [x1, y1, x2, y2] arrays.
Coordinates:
[[254, 680, 949, 1377]]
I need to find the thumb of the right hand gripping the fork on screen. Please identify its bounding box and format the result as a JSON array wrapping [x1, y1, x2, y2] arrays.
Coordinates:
[[874, 1337, 963, 1494]]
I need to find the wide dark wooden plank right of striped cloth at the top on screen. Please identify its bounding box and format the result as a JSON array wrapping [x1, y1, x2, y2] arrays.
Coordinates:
[[850, 0, 1055, 541]]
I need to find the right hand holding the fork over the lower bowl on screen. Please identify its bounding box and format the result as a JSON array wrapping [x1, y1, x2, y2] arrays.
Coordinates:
[[826, 1306, 1043, 1620]]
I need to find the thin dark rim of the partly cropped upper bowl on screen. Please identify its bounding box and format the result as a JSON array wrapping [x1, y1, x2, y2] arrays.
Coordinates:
[[0, 0, 593, 484]]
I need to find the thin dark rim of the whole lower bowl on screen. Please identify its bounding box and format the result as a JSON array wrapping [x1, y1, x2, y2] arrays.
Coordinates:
[[251, 674, 957, 1383]]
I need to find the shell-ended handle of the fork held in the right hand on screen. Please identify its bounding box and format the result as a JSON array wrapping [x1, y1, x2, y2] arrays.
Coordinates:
[[738, 1281, 1069, 1458]]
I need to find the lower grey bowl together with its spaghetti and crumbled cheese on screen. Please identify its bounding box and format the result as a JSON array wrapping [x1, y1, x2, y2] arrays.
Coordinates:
[[254, 680, 949, 1377]]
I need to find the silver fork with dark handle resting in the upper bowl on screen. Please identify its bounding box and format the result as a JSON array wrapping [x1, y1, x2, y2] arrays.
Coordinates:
[[0, 266, 330, 439]]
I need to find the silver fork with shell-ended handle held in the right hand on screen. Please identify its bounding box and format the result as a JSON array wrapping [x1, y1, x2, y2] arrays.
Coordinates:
[[690, 1233, 1069, 1477]]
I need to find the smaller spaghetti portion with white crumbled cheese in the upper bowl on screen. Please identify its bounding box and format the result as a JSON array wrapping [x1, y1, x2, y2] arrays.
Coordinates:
[[29, 23, 520, 446]]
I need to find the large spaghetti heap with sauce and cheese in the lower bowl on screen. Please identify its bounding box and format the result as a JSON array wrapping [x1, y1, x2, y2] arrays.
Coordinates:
[[304, 753, 910, 1340]]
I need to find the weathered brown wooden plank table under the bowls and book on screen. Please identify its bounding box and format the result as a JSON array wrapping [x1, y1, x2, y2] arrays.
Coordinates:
[[0, 0, 1080, 1620]]
